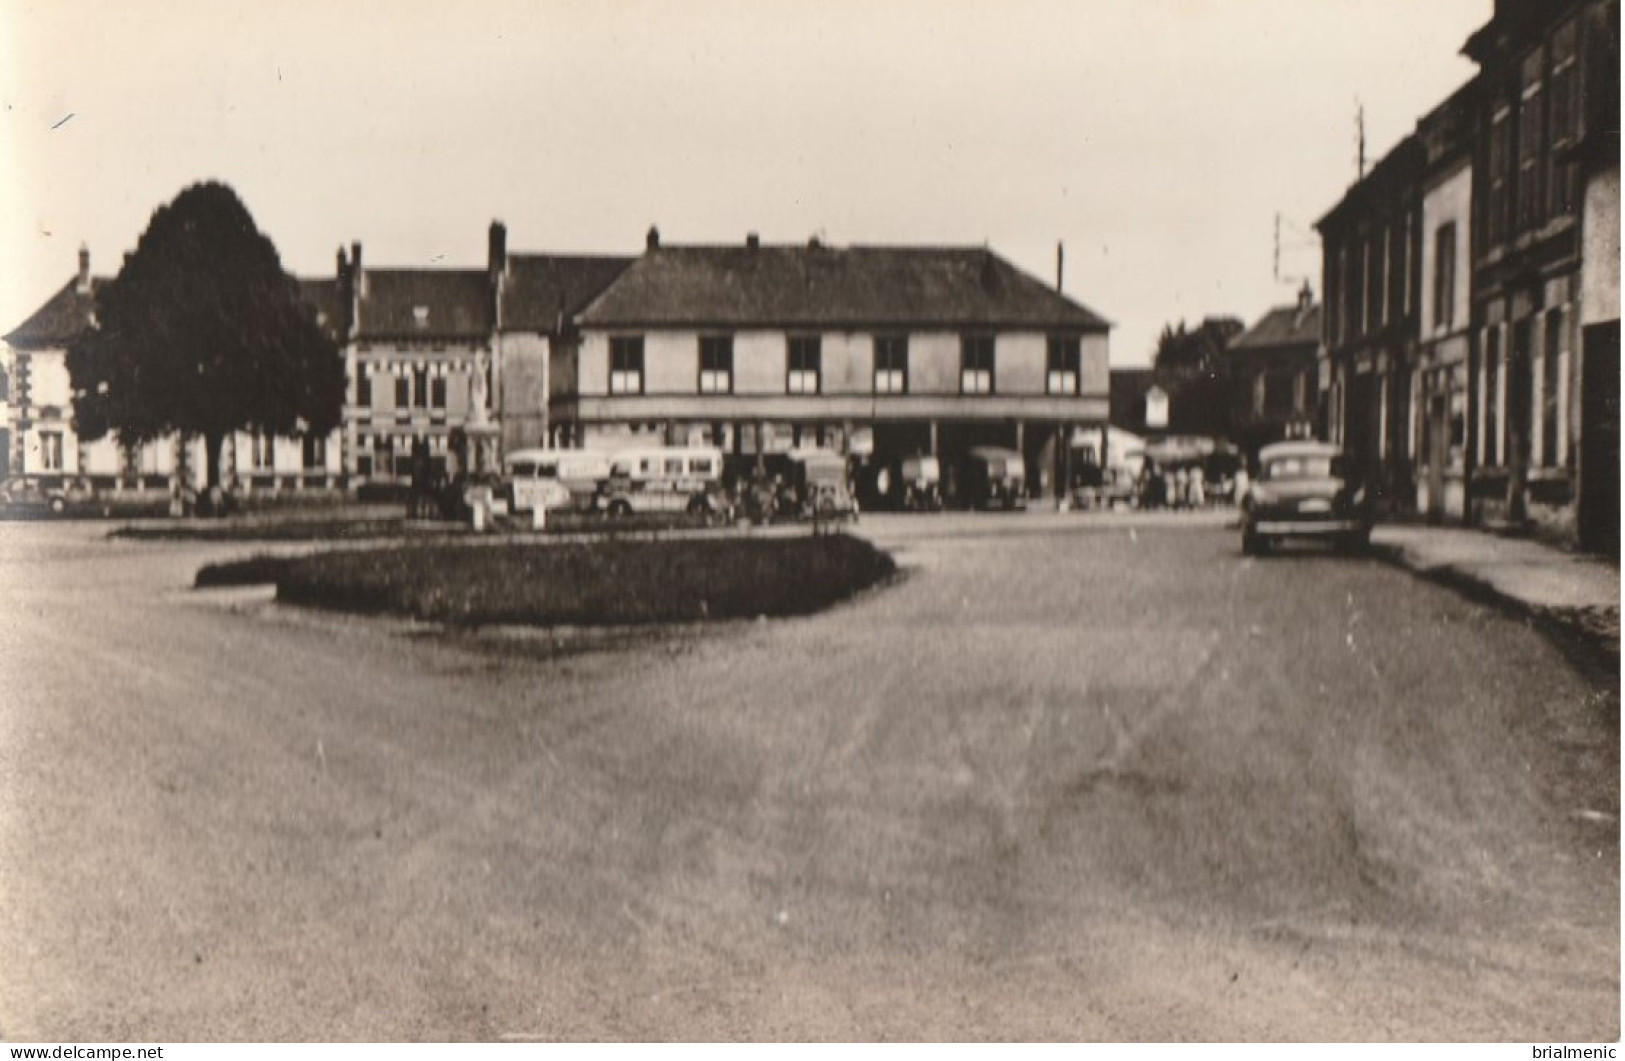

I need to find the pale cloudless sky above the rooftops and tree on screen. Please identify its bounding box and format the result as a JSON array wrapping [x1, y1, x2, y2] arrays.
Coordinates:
[[0, 0, 1492, 366]]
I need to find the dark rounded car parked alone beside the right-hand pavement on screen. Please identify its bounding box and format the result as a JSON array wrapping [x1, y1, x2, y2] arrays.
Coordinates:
[[1242, 442, 1373, 556]]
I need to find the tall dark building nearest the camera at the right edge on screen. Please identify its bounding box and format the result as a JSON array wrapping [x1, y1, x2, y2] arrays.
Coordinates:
[[1466, 0, 1620, 548]]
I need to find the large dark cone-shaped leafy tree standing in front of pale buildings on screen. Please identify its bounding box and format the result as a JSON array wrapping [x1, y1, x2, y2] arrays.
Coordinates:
[[68, 182, 345, 487]]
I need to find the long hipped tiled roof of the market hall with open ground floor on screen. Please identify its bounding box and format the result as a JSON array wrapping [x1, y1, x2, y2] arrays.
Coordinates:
[[577, 245, 1110, 331]]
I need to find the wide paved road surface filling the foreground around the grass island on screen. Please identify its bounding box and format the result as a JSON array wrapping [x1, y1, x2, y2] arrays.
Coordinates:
[[0, 517, 1620, 1042]]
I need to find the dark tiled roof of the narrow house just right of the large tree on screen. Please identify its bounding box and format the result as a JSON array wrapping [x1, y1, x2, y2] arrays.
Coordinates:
[[358, 270, 494, 340]]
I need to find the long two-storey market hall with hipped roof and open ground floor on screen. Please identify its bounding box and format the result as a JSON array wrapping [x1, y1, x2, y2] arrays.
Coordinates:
[[562, 229, 1110, 496]]
